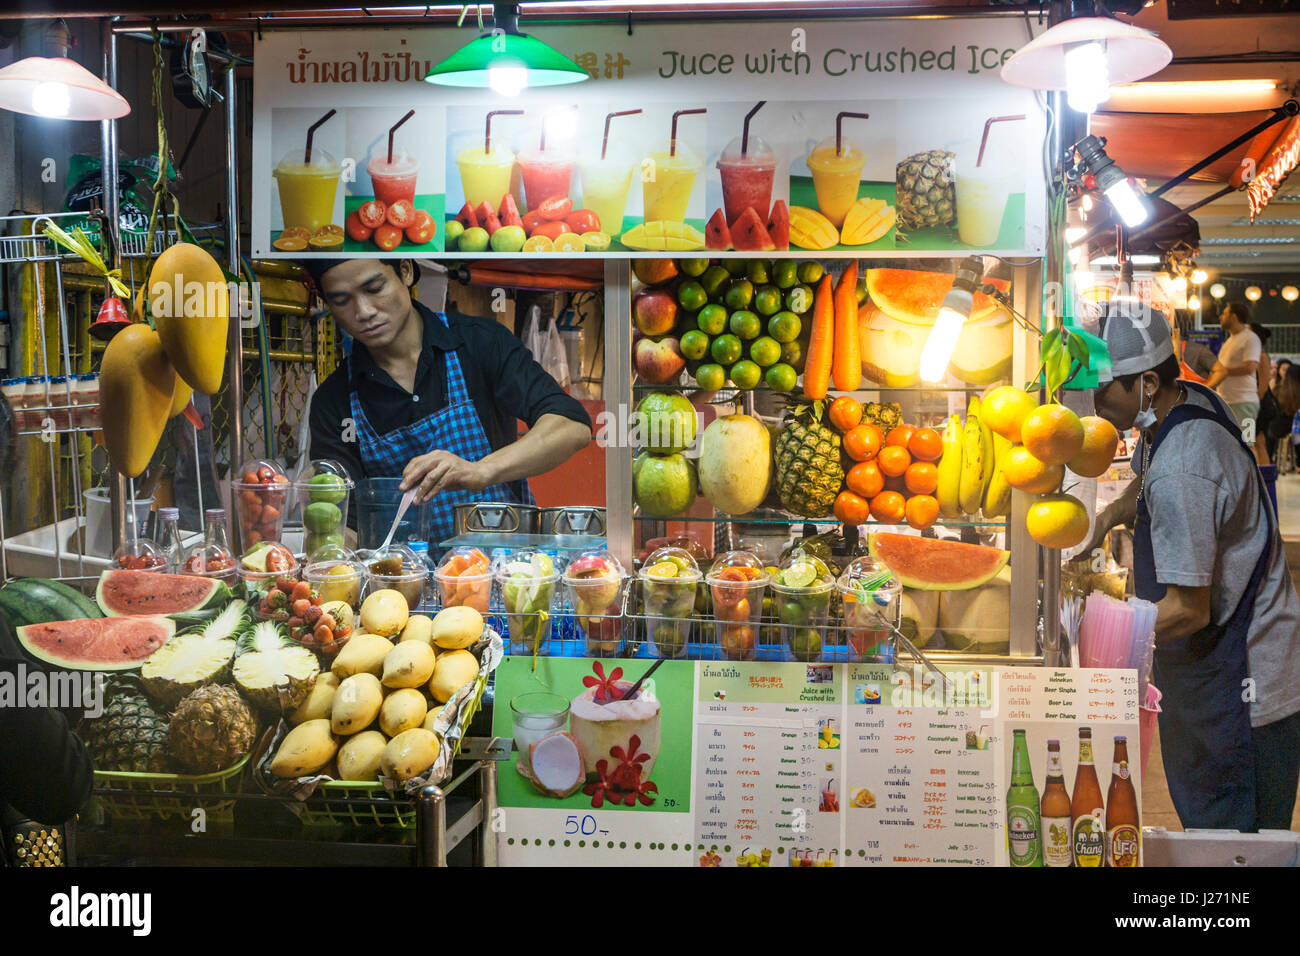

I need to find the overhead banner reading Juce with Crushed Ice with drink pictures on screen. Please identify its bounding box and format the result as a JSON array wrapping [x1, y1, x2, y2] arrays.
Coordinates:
[[252, 18, 1047, 258]]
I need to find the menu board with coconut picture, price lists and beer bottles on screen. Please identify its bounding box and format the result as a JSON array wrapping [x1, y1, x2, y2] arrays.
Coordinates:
[[494, 658, 1141, 866]]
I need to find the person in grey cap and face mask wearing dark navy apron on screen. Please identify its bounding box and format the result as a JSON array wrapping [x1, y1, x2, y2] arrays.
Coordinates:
[[1092, 303, 1300, 832]]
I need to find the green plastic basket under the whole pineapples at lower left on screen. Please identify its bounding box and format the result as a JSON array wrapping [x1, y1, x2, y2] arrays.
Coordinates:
[[95, 753, 251, 823]]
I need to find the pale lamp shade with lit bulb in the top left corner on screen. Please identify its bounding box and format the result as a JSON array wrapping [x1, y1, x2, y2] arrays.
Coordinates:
[[0, 56, 131, 120]]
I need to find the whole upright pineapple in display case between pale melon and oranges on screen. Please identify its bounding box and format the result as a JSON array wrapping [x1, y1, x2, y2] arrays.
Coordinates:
[[776, 401, 844, 518]]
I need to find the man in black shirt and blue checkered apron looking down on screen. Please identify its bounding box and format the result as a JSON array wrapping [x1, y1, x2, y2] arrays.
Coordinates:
[[304, 259, 592, 548]]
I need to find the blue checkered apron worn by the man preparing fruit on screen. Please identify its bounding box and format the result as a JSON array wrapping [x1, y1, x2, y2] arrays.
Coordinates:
[[348, 312, 536, 548]]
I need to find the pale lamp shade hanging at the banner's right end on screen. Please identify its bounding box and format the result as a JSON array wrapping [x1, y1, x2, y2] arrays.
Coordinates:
[[1002, 17, 1174, 90]]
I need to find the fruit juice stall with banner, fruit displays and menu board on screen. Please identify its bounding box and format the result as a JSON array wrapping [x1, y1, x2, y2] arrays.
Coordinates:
[[0, 3, 1138, 866]]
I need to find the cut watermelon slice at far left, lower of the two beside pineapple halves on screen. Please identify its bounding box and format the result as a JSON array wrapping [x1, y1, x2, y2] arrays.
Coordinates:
[[17, 613, 175, 671]]
